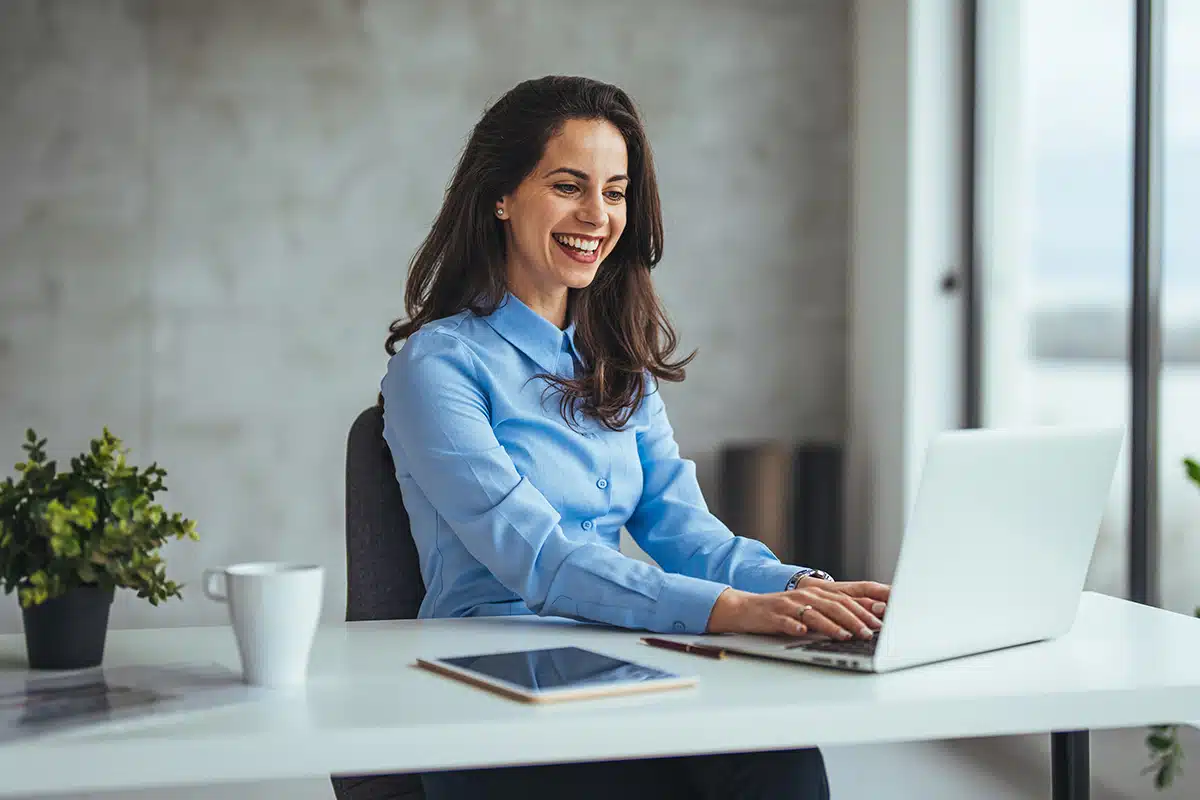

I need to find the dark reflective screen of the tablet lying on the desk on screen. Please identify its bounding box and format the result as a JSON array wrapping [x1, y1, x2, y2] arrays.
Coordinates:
[[438, 648, 678, 692]]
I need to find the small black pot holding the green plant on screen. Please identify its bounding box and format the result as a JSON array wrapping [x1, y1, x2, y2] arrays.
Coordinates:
[[22, 587, 113, 669]]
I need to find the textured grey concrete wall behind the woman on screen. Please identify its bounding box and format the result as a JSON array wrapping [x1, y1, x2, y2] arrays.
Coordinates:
[[0, 0, 850, 632]]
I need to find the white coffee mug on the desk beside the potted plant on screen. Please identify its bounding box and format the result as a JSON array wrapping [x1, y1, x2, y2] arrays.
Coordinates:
[[204, 561, 325, 687]]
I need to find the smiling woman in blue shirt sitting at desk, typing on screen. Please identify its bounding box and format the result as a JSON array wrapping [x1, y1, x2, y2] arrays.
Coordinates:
[[382, 77, 888, 800]]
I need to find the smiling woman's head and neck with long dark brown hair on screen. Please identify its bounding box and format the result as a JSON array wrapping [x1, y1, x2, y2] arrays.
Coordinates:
[[388, 77, 691, 427]]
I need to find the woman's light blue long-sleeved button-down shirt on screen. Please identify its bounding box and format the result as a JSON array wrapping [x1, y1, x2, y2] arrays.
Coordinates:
[[382, 295, 800, 633]]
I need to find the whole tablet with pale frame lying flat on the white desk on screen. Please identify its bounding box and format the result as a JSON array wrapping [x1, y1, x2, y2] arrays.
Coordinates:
[[416, 648, 697, 703]]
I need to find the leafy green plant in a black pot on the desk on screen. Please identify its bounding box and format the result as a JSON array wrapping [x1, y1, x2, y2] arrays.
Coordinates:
[[0, 428, 198, 669]]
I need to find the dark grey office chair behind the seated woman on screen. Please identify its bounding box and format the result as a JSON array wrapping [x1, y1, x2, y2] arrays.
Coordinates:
[[331, 405, 425, 800]]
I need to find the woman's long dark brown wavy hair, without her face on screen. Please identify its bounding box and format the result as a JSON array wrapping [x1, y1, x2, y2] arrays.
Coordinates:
[[386, 76, 696, 429]]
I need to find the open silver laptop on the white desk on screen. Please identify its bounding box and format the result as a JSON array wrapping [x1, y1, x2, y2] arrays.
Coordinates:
[[703, 428, 1124, 673]]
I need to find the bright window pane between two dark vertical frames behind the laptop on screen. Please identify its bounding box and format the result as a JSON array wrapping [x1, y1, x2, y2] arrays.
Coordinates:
[[977, 0, 1132, 595]]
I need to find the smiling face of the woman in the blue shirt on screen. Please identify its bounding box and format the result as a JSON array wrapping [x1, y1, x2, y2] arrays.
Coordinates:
[[497, 120, 629, 302]]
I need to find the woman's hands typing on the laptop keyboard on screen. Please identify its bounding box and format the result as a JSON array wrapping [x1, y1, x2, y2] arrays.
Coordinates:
[[708, 584, 886, 639]]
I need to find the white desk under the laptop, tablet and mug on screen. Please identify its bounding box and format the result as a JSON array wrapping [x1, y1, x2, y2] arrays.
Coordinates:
[[0, 594, 1200, 798]]
